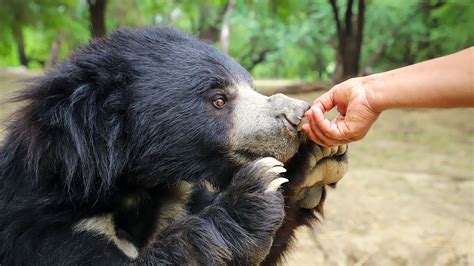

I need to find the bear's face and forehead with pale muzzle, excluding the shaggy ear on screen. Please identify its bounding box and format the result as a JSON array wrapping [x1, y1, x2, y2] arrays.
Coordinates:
[[122, 29, 309, 187]]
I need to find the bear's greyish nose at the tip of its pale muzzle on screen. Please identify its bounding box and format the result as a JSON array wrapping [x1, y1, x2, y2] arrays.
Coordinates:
[[270, 93, 311, 127]]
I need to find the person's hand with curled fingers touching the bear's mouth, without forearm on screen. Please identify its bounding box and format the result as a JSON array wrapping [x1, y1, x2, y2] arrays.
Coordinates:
[[302, 77, 380, 146]]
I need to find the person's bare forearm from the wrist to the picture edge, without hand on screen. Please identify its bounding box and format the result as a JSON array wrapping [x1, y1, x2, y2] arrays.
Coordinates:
[[363, 47, 474, 112]]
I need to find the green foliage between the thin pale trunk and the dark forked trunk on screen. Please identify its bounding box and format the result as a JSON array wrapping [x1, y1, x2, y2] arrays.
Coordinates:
[[230, 0, 335, 80]]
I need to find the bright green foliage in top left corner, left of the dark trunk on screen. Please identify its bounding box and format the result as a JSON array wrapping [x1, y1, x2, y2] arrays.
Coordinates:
[[0, 0, 90, 68]]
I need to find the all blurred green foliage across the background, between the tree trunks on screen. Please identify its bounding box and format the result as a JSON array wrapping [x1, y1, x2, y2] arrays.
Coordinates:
[[0, 0, 474, 81]]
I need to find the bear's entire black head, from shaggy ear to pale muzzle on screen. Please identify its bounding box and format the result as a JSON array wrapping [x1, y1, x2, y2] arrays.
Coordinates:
[[13, 28, 334, 198]]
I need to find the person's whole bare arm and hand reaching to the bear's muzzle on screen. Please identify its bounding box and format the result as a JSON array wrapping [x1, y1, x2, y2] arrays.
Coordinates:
[[303, 47, 474, 146]]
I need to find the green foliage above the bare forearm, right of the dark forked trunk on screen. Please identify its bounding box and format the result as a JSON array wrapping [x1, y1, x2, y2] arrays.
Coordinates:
[[362, 0, 474, 72]]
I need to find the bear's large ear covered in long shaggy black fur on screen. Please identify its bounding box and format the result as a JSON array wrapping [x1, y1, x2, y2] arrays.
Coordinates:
[[11, 68, 131, 200]]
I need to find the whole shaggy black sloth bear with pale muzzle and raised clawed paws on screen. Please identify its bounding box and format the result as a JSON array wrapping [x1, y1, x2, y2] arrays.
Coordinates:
[[0, 28, 347, 265]]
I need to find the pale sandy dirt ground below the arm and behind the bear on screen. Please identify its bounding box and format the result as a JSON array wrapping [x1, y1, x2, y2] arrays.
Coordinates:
[[0, 72, 474, 266]]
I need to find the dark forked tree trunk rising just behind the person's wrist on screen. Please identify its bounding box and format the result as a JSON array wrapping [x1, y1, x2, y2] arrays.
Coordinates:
[[329, 0, 365, 83]]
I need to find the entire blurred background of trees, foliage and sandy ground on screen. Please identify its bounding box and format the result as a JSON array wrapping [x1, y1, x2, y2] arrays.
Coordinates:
[[0, 0, 474, 265]]
